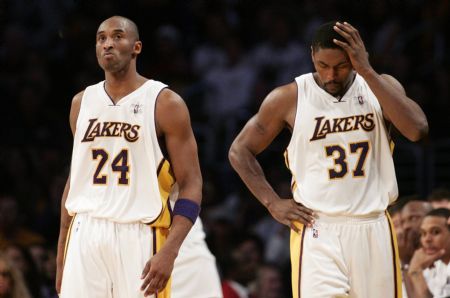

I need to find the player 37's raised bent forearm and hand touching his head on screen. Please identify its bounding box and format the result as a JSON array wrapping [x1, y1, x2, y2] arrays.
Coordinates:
[[334, 22, 428, 142]]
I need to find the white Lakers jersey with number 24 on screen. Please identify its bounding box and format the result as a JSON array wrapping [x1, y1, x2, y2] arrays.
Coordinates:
[[65, 80, 174, 226]]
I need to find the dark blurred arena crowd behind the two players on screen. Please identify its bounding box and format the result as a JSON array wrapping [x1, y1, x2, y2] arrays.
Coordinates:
[[0, 0, 450, 298]]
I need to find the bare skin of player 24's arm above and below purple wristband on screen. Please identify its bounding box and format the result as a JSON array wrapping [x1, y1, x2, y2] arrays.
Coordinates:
[[141, 89, 202, 295]]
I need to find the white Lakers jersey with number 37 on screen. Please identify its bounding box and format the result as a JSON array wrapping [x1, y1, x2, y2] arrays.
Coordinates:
[[286, 73, 398, 216]]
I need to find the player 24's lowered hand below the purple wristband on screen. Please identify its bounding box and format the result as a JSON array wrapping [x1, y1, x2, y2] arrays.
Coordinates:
[[141, 249, 176, 297]]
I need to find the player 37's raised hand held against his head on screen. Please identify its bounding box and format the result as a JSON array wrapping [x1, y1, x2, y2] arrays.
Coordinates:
[[333, 22, 372, 74]]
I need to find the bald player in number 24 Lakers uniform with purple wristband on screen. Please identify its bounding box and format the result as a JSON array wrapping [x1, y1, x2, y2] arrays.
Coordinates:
[[56, 16, 202, 298]]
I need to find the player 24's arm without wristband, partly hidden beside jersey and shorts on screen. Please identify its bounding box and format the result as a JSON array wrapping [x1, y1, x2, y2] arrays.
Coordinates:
[[55, 91, 84, 294]]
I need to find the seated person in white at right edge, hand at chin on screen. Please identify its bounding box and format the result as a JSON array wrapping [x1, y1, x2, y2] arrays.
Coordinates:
[[405, 208, 450, 298]]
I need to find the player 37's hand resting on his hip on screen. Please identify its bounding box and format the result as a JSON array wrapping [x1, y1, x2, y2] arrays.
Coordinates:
[[269, 199, 314, 232]]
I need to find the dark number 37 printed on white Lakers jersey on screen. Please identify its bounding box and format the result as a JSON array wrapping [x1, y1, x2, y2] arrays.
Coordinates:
[[325, 141, 370, 179]]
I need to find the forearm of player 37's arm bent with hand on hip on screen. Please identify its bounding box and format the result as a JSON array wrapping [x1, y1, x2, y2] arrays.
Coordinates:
[[229, 144, 279, 209]]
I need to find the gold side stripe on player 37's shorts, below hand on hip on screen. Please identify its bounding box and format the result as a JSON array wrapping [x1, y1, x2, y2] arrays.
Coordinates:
[[290, 222, 306, 298]]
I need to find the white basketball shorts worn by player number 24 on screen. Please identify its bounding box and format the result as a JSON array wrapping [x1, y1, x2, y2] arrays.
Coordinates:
[[60, 214, 170, 298]]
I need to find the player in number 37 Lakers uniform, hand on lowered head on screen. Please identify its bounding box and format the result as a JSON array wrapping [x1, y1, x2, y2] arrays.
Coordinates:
[[229, 22, 428, 298]]
